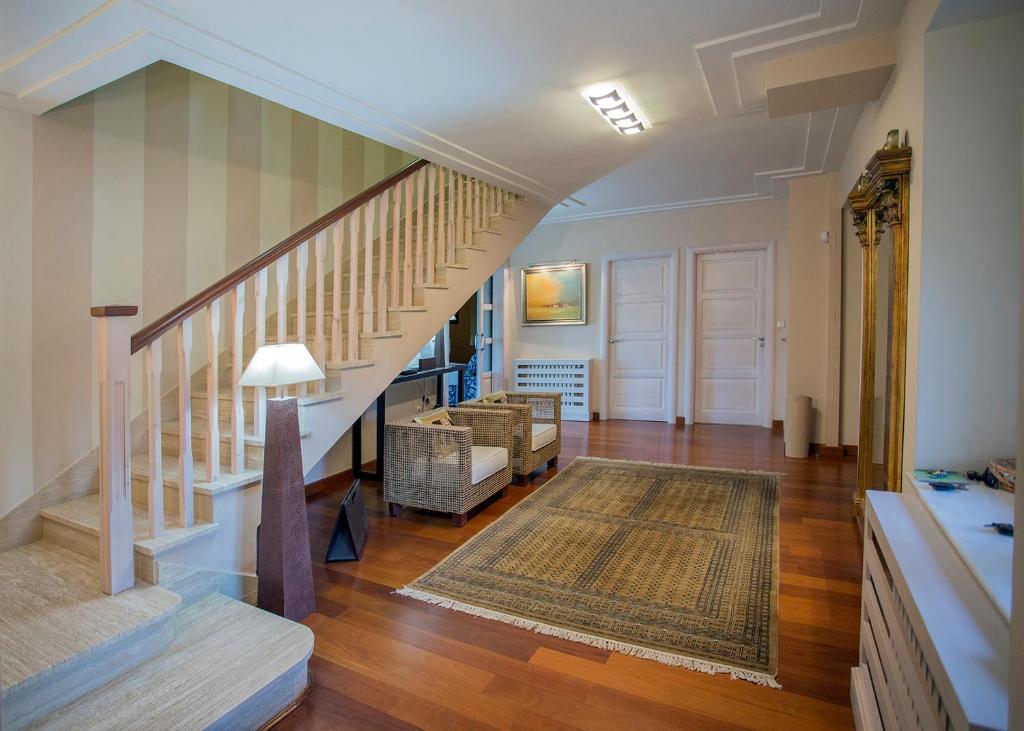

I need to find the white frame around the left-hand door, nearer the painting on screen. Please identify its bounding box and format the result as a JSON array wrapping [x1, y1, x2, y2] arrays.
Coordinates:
[[598, 249, 679, 424]]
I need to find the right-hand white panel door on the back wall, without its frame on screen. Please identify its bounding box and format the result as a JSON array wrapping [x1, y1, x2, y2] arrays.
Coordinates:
[[694, 250, 769, 426]]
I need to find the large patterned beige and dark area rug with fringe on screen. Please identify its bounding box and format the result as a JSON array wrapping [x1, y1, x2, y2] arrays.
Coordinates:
[[398, 458, 780, 688]]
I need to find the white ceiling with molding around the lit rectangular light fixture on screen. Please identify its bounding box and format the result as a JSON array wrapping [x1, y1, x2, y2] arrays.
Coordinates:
[[0, 0, 905, 218]]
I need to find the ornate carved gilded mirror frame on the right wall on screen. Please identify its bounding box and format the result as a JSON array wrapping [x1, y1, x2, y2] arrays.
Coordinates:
[[847, 137, 911, 515]]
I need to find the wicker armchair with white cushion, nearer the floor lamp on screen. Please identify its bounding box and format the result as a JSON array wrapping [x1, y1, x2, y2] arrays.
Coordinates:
[[384, 409, 512, 525]]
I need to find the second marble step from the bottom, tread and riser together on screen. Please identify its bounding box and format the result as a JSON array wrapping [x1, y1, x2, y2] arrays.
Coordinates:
[[0, 540, 181, 731]]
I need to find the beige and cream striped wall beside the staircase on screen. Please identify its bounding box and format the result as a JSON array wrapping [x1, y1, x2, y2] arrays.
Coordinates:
[[0, 62, 414, 516]]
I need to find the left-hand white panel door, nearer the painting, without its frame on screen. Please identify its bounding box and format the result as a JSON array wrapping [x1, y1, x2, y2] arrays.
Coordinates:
[[606, 254, 675, 421]]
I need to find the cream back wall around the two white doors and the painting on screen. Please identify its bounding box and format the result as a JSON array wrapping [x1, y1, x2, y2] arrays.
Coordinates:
[[509, 200, 788, 419]]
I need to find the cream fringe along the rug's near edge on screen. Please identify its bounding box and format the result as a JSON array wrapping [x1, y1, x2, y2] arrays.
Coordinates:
[[394, 587, 782, 688]]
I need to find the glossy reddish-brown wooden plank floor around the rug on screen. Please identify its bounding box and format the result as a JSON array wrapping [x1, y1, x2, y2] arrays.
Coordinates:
[[279, 421, 861, 731]]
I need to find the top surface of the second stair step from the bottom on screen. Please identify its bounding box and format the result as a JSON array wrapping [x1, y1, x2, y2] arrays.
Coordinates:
[[0, 541, 181, 695]]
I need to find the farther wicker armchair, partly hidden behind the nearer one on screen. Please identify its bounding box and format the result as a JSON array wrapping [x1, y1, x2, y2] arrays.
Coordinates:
[[459, 391, 562, 484]]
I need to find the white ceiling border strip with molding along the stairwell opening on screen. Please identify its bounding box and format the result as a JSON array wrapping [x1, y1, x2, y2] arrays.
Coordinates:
[[0, 0, 579, 205]]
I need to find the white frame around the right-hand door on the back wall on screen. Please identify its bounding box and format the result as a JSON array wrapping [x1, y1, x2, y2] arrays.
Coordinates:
[[683, 239, 775, 427]]
